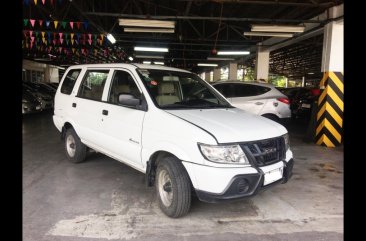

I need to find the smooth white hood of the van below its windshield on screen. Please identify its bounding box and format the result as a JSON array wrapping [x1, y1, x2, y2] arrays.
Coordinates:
[[166, 108, 287, 143]]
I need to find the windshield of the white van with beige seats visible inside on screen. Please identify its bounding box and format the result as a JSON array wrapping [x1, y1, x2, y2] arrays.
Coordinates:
[[136, 69, 232, 109]]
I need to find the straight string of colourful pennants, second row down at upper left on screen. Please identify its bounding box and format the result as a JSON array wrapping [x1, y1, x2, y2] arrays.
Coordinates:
[[23, 18, 89, 30]]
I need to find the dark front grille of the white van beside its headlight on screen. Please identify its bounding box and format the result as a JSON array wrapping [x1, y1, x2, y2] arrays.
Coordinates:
[[240, 137, 286, 166]]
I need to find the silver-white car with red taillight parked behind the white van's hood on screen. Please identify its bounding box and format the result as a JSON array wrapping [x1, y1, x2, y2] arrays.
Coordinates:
[[212, 81, 291, 123]]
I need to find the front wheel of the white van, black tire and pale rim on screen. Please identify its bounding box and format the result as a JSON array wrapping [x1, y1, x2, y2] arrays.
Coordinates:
[[155, 157, 191, 218]]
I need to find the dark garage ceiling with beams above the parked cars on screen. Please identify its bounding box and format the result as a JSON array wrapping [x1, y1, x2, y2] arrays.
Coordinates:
[[22, 0, 343, 74]]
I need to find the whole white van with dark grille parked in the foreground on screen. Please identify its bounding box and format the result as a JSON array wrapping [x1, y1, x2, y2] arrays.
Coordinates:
[[53, 64, 294, 217]]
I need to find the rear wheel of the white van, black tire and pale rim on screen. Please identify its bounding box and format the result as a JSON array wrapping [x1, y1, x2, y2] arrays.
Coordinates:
[[65, 128, 86, 163]]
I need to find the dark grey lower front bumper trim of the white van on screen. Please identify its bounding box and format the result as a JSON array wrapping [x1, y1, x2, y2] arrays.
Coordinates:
[[196, 158, 294, 203]]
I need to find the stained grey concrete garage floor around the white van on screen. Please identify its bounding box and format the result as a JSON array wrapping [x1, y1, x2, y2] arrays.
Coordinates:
[[23, 113, 343, 241]]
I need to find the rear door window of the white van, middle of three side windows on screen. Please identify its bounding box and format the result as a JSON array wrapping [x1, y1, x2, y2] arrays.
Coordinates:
[[78, 70, 109, 100]]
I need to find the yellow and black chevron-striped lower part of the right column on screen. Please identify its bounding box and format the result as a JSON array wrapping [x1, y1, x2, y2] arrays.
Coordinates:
[[315, 72, 344, 147]]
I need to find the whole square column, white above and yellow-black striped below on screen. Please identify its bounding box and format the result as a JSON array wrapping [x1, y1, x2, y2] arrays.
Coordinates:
[[313, 19, 344, 147]]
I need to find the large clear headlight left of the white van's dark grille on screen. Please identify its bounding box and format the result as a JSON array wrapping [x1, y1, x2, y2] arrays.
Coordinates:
[[198, 144, 249, 164]]
